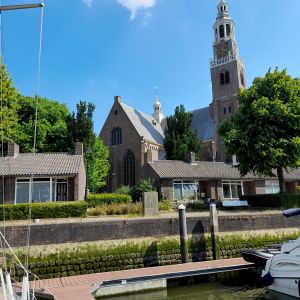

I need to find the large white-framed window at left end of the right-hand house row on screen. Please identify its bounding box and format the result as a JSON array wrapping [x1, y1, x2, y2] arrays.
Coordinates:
[[173, 180, 198, 200]]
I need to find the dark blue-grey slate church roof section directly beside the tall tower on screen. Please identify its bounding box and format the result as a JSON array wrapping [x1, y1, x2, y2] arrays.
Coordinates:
[[192, 106, 216, 141]]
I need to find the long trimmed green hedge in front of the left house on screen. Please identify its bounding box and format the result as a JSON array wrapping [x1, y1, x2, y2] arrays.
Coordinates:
[[0, 201, 87, 221]]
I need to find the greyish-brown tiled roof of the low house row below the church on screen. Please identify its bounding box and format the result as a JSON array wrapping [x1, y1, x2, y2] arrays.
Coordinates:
[[149, 160, 300, 180]]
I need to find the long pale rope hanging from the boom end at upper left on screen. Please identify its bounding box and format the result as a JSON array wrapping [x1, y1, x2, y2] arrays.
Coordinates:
[[25, 0, 44, 269]]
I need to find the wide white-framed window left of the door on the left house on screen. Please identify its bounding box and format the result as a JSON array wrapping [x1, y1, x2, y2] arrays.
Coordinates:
[[15, 178, 53, 204]]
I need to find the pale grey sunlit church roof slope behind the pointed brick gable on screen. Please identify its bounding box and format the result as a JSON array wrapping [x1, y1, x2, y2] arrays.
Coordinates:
[[120, 103, 165, 145]]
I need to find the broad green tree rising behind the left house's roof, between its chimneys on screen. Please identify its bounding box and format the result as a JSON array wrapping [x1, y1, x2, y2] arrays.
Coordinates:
[[14, 97, 71, 153]]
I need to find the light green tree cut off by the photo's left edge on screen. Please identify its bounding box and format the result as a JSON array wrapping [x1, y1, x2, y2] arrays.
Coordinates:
[[0, 64, 19, 142]]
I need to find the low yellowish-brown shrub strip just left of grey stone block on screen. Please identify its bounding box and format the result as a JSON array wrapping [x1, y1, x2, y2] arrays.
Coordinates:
[[88, 203, 143, 216]]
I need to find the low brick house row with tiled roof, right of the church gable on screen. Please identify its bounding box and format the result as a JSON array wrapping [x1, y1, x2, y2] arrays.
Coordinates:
[[143, 153, 300, 200]]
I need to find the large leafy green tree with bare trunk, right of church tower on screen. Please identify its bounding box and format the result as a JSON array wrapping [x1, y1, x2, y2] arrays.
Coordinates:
[[218, 68, 300, 192]]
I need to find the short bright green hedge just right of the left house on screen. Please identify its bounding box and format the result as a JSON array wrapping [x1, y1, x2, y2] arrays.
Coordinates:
[[86, 194, 132, 207]]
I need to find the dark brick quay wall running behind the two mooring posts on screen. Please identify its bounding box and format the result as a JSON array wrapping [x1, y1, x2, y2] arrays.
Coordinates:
[[0, 212, 300, 247]]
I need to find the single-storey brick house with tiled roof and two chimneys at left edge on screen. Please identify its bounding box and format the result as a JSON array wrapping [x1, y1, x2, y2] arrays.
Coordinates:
[[0, 142, 86, 204]]
